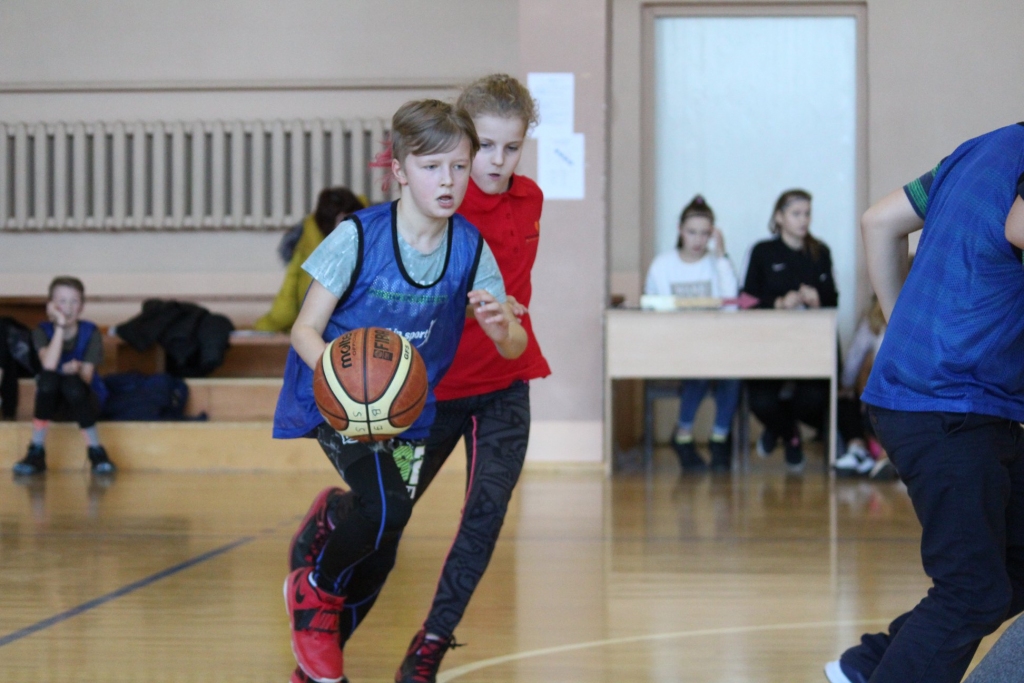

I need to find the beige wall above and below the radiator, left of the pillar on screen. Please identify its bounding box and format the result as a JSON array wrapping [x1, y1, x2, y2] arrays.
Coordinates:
[[0, 0, 518, 309]]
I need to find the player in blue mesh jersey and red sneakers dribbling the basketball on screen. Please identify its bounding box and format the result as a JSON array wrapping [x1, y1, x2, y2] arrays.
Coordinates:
[[273, 100, 526, 682]]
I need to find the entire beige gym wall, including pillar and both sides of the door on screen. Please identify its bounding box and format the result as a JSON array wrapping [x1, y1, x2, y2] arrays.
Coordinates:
[[0, 0, 1011, 461]]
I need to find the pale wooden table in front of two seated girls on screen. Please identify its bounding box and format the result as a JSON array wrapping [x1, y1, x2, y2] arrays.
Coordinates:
[[604, 308, 839, 470]]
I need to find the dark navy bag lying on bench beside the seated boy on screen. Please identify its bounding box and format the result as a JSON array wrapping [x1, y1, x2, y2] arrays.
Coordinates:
[[100, 373, 188, 421]]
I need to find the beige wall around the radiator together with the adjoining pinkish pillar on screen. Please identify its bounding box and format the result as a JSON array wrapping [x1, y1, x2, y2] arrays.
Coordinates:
[[0, 0, 607, 462]]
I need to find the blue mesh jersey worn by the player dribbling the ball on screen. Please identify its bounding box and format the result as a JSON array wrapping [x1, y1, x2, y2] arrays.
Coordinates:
[[273, 202, 483, 440]]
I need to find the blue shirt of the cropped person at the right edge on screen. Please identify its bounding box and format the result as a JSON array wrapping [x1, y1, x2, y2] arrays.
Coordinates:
[[863, 124, 1024, 422]]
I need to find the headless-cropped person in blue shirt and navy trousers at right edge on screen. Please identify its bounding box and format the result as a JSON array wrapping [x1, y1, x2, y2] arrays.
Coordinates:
[[825, 125, 1024, 683]]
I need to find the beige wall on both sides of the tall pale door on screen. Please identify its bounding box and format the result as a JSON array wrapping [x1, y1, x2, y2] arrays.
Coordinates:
[[609, 0, 1024, 311]]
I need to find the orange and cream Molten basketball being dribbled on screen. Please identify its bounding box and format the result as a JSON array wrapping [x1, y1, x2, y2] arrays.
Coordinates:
[[313, 328, 427, 441]]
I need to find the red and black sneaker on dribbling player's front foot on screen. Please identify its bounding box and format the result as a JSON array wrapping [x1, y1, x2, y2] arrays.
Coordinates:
[[285, 567, 345, 683]]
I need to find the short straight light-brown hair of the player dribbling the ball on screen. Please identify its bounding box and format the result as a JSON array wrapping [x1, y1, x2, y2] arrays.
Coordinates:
[[391, 99, 480, 163]]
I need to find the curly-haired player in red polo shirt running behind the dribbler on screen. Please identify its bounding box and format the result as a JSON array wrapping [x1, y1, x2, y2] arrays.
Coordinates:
[[395, 74, 551, 683]]
